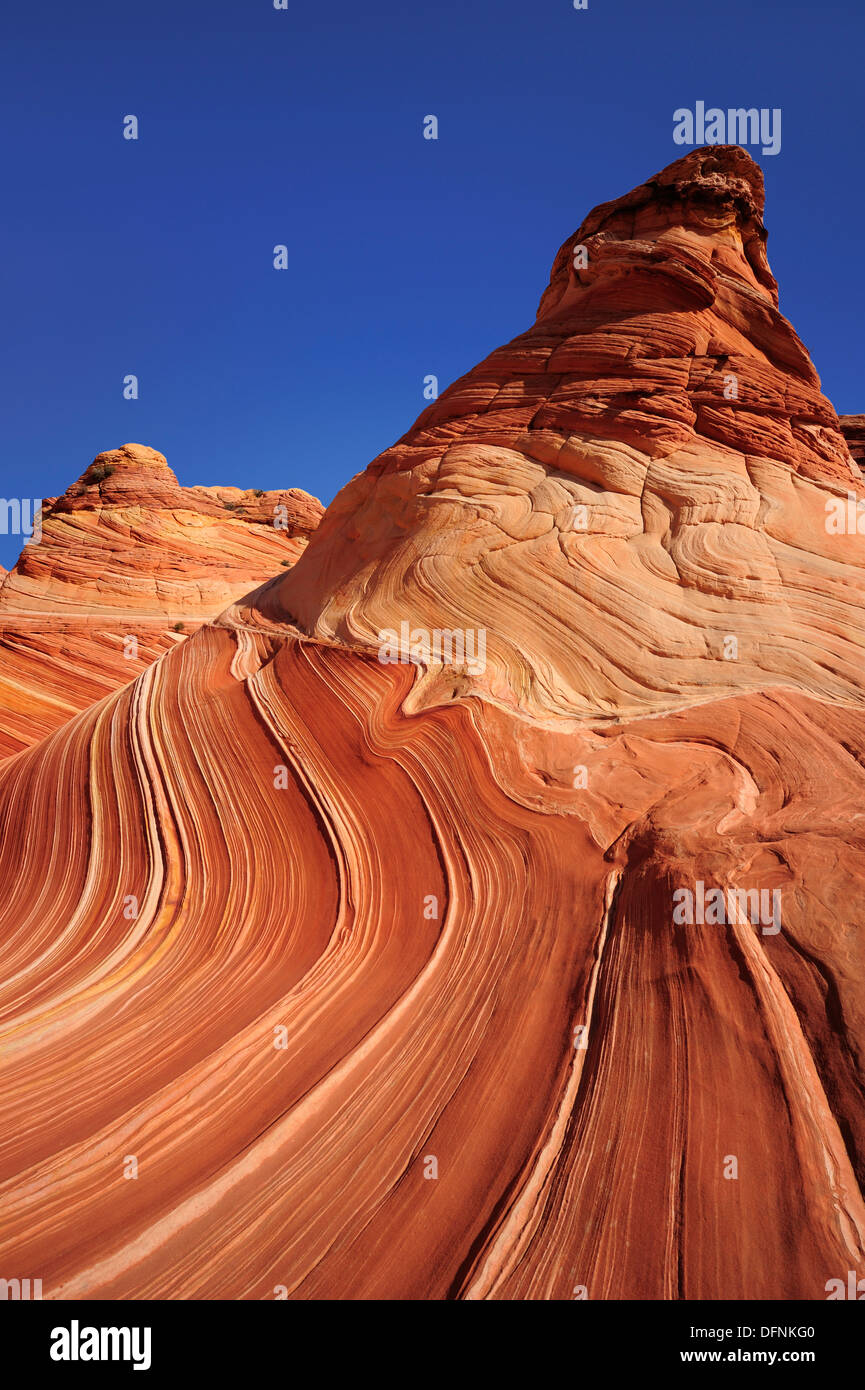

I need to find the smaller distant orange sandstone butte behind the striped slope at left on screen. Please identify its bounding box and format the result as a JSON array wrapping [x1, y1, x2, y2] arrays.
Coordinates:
[[0, 443, 323, 758]]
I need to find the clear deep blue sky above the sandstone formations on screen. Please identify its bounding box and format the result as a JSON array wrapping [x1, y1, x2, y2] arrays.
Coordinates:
[[0, 0, 865, 566]]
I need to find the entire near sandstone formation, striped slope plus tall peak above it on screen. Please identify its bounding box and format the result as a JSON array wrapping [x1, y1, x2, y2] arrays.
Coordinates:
[[0, 147, 865, 1300]]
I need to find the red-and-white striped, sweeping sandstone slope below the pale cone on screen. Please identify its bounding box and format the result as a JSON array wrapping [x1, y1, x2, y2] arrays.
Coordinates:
[[0, 627, 865, 1300]]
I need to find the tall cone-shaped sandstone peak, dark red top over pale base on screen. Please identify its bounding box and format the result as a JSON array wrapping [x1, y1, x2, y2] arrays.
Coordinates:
[[271, 146, 865, 719]]
